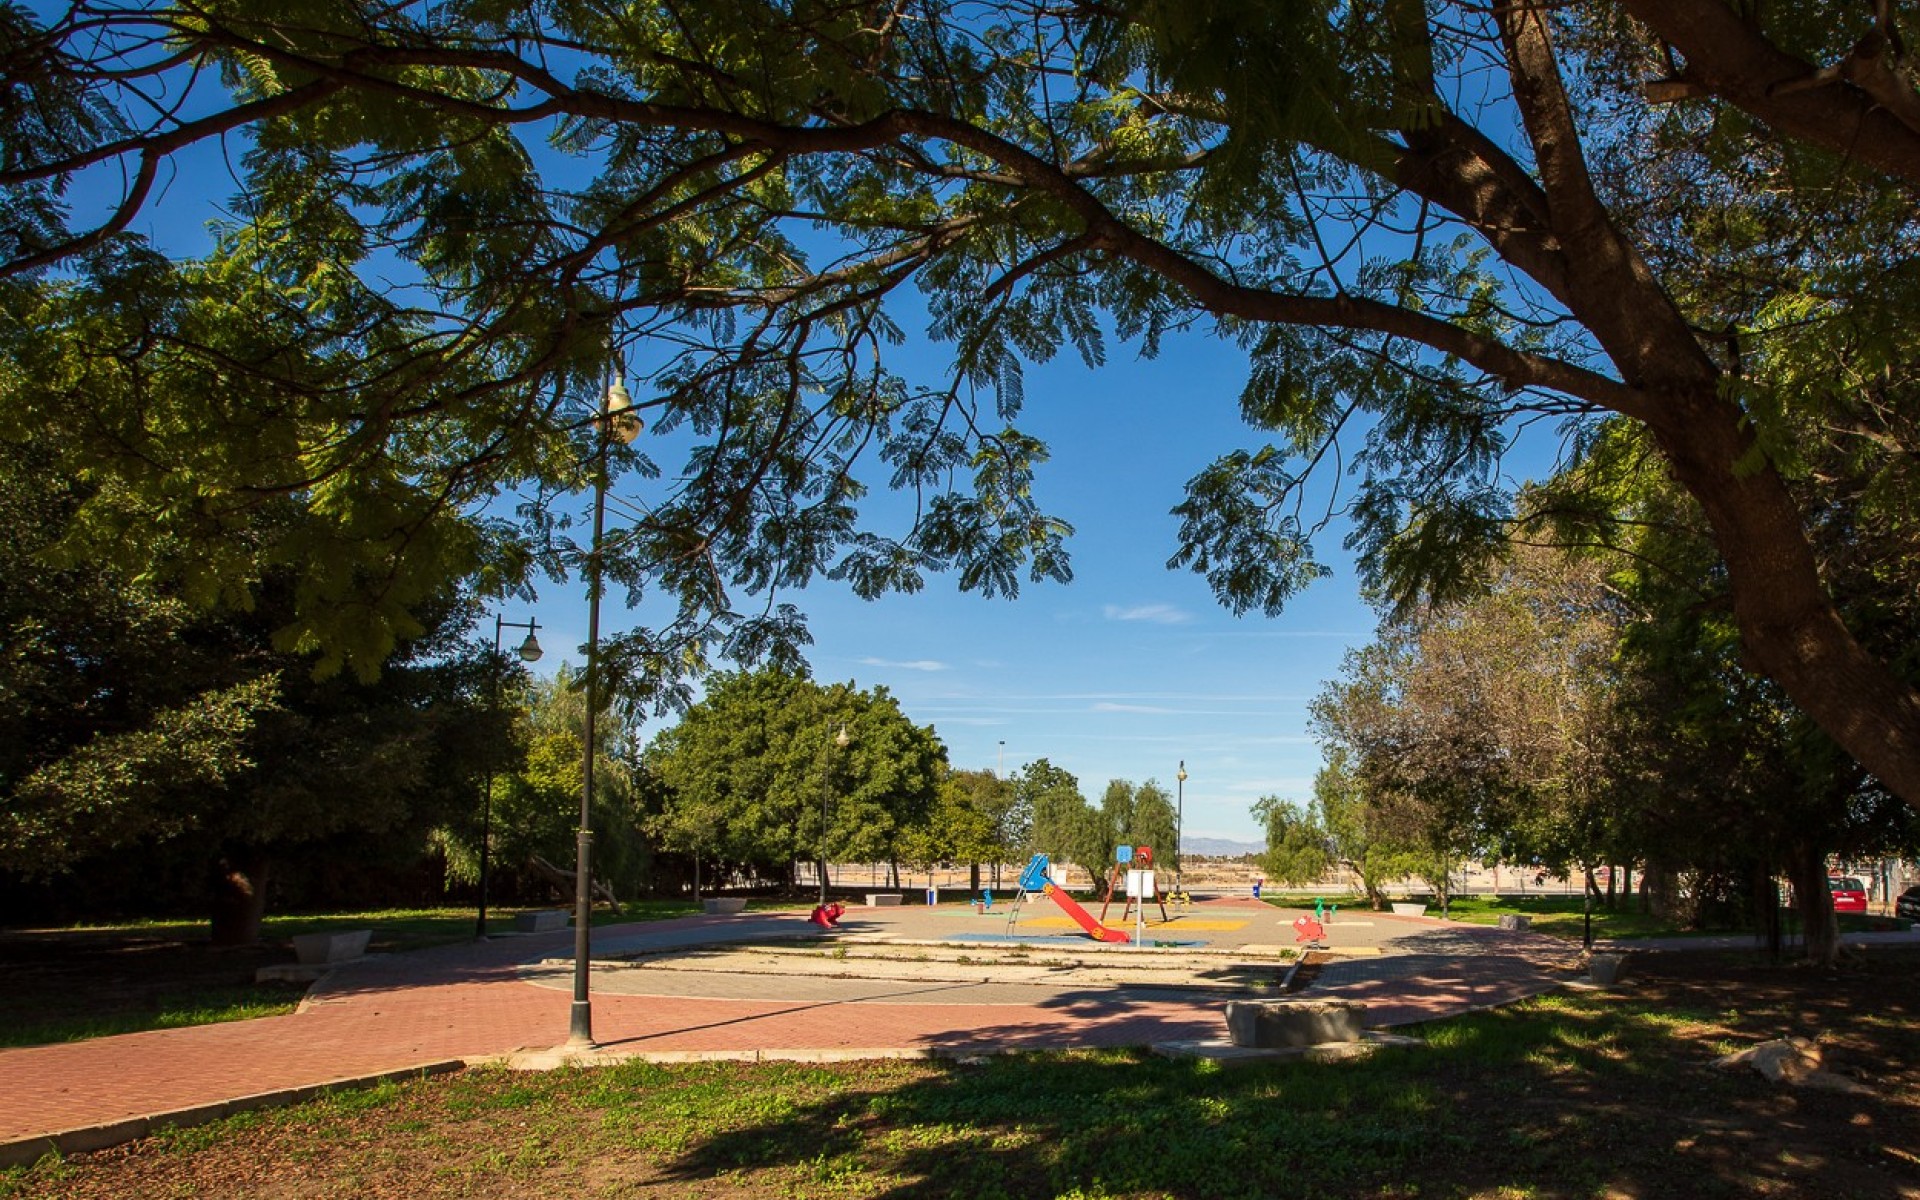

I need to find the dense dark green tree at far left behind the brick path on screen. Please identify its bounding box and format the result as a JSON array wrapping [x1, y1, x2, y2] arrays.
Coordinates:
[[0, 442, 492, 943]]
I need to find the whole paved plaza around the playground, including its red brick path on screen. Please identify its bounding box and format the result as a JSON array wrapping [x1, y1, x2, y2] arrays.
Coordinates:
[[0, 899, 1578, 1162]]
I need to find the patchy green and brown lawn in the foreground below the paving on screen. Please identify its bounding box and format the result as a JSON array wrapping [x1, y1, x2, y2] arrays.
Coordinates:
[[0, 948, 1920, 1200]]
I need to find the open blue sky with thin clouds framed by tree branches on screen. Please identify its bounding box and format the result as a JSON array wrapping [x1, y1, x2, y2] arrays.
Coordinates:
[[526, 334, 1373, 841]]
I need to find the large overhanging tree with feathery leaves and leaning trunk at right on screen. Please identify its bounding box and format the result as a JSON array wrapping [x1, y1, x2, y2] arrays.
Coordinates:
[[11, 0, 1920, 804]]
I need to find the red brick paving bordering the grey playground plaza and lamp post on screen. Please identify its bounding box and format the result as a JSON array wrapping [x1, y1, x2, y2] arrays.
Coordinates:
[[0, 918, 1540, 1142]]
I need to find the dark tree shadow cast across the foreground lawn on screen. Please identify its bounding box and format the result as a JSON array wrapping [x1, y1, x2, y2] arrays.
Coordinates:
[[614, 948, 1920, 1198]]
